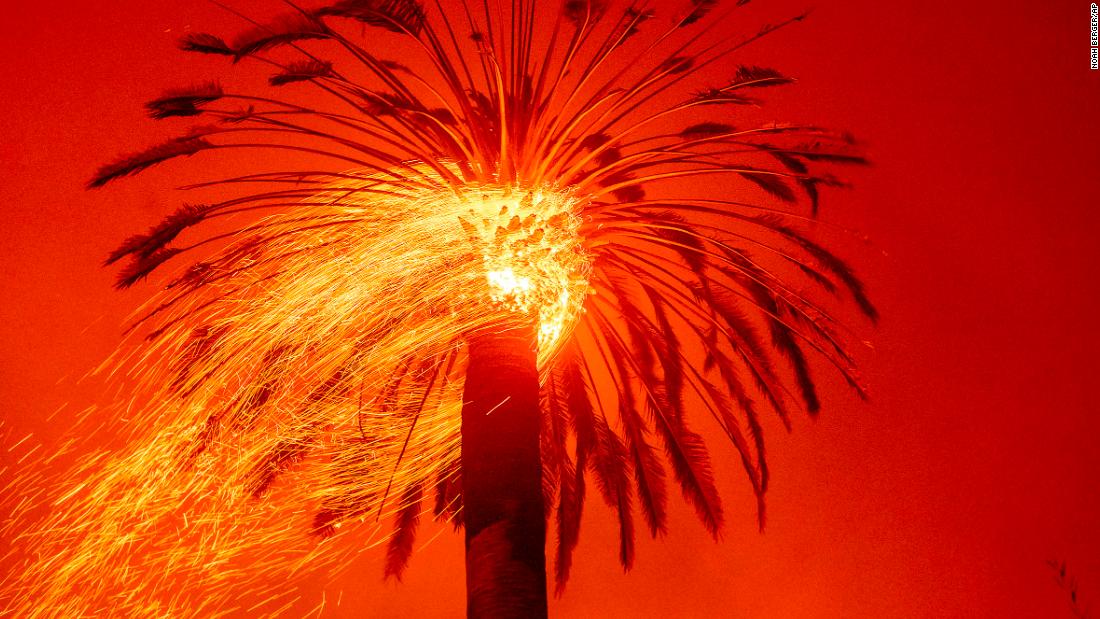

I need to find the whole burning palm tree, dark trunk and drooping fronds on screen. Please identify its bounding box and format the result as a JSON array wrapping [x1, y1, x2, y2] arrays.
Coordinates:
[[12, 0, 876, 617]]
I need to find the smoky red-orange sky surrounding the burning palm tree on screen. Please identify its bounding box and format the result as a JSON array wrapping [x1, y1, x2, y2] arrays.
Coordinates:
[[0, 0, 1100, 618]]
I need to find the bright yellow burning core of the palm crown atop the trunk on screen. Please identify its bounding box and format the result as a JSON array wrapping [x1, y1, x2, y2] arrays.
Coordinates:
[[457, 187, 590, 351]]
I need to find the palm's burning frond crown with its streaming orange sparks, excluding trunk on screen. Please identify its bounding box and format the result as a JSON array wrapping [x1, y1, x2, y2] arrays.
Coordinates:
[[3, 0, 877, 617]]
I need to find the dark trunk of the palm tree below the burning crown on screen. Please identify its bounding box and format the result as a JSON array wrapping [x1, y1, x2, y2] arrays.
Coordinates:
[[462, 327, 547, 619]]
